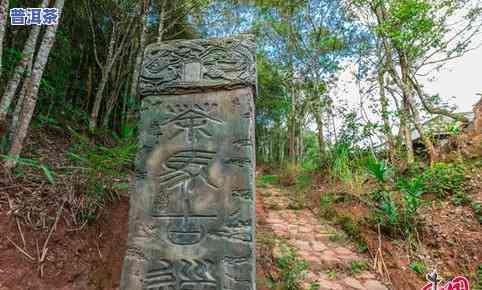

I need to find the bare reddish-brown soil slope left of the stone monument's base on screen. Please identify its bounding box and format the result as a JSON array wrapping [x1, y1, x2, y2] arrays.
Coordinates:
[[0, 198, 129, 290]]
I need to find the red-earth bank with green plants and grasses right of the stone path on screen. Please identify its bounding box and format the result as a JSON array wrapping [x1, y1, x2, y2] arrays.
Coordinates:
[[257, 139, 482, 289]]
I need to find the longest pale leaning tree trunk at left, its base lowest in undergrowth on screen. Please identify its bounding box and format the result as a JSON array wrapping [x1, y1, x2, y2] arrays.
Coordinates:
[[5, 0, 65, 168]]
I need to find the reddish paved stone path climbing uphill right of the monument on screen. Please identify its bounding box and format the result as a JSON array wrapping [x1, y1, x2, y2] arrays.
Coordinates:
[[257, 185, 388, 290]]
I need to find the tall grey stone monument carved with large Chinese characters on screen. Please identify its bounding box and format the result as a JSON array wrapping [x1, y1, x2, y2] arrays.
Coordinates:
[[121, 36, 256, 290]]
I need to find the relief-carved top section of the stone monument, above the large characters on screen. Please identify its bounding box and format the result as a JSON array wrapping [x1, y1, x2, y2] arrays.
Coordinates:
[[139, 37, 256, 97]]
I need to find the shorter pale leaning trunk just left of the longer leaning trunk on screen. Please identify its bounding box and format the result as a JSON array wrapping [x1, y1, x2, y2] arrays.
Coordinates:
[[0, 0, 49, 128]]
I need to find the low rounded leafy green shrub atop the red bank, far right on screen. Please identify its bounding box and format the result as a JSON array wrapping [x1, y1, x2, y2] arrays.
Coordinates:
[[422, 162, 465, 198]]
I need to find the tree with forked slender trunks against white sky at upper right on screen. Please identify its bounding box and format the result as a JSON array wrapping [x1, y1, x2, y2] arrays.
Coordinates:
[[353, 0, 482, 163]]
